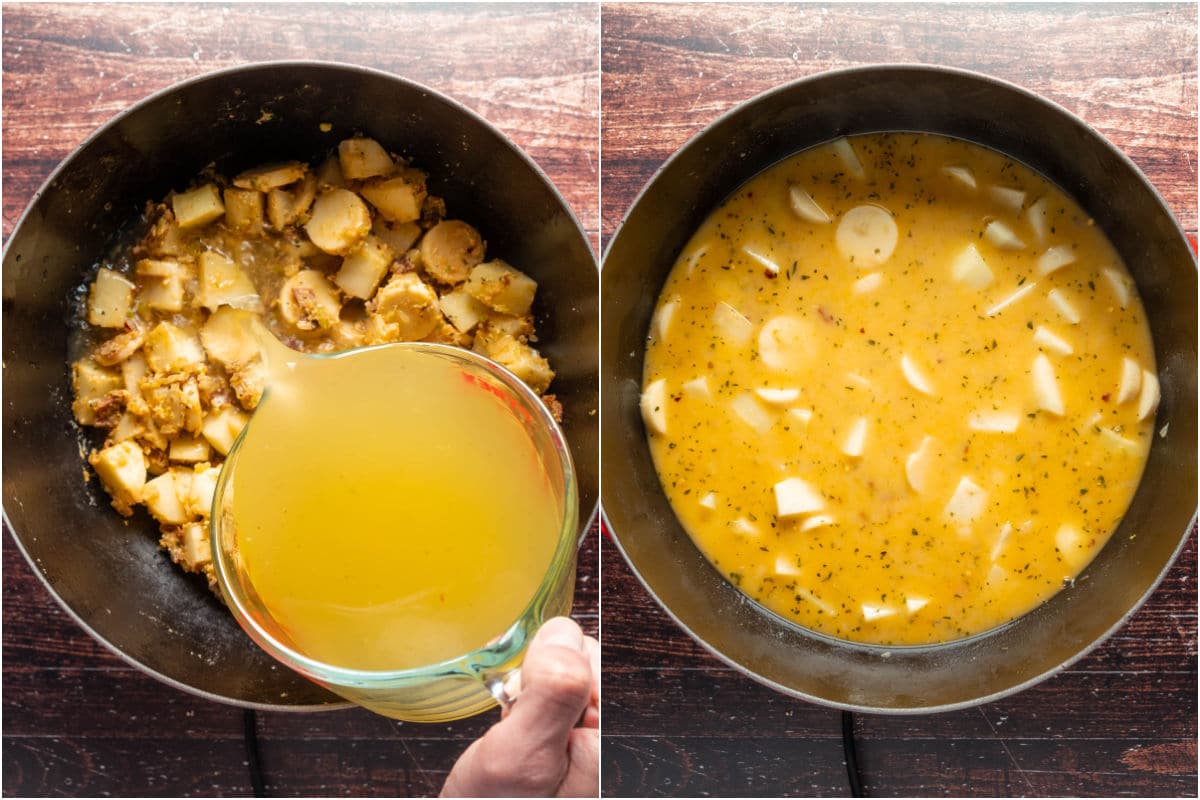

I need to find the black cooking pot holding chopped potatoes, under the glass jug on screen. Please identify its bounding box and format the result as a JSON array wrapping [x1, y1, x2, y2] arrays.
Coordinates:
[[4, 62, 598, 709]]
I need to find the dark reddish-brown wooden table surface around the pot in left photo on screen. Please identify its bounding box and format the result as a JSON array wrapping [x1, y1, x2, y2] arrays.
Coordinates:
[[2, 4, 600, 795]]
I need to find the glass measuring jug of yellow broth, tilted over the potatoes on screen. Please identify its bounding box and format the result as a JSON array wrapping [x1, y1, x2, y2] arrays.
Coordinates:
[[212, 330, 577, 722]]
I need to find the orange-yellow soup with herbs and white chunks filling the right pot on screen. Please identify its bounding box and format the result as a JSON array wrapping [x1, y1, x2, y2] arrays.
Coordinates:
[[642, 134, 1158, 645]]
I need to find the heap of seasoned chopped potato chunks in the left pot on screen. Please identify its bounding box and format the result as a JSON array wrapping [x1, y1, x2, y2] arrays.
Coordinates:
[[71, 138, 563, 591]]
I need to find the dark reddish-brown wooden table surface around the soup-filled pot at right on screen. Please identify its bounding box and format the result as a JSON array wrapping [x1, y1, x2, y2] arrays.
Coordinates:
[[601, 4, 1196, 796]]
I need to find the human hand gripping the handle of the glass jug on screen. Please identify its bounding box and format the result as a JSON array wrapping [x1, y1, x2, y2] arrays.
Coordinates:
[[442, 616, 600, 798]]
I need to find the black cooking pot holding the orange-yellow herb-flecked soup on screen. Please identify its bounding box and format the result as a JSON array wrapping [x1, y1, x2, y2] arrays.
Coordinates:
[[600, 66, 1196, 712]]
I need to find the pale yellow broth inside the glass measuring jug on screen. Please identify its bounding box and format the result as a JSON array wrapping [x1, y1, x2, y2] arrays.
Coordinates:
[[233, 348, 563, 670]]
